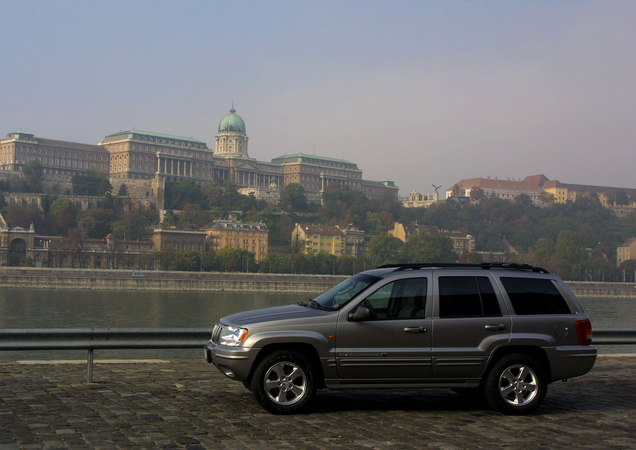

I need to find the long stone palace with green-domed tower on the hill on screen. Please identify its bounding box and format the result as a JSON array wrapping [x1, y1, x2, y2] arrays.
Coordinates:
[[0, 108, 398, 201]]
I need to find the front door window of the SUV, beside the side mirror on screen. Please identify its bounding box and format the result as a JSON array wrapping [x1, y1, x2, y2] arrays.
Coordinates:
[[365, 278, 428, 319]]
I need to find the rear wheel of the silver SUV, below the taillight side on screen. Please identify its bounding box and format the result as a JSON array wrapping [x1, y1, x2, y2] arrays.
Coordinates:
[[484, 353, 548, 415]]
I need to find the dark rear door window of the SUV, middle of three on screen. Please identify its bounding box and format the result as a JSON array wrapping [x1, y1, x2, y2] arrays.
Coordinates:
[[438, 277, 501, 317]]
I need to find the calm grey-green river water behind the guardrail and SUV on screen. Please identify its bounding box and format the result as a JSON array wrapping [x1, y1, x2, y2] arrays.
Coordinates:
[[0, 289, 636, 361]]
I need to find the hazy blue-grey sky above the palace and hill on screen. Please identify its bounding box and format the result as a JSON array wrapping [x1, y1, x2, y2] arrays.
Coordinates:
[[0, 0, 636, 195]]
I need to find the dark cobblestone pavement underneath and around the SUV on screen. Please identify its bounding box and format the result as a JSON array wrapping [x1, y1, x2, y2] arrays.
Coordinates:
[[0, 357, 636, 450]]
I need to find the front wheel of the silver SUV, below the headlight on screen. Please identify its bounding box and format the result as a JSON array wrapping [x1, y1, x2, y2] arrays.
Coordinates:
[[251, 350, 316, 414]]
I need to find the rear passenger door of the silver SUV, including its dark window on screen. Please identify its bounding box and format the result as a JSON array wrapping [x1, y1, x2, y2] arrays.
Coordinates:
[[431, 274, 511, 380]]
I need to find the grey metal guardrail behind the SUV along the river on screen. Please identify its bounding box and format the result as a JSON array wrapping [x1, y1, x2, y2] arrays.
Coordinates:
[[0, 328, 636, 383]]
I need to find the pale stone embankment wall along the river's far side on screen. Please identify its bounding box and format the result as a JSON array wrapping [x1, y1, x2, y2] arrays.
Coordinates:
[[0, 267, 636, 299]]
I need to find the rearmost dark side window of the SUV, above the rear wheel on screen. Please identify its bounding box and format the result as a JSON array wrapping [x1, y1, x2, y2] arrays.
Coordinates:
[[501, 277, 571, 316]]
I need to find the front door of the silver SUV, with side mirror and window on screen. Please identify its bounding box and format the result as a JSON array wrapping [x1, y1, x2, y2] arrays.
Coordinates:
[[336, 276, 432, 384]]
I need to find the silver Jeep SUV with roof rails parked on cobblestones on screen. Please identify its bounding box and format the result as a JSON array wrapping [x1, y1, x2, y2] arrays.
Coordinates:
[[205, 263, 596, 414]]
